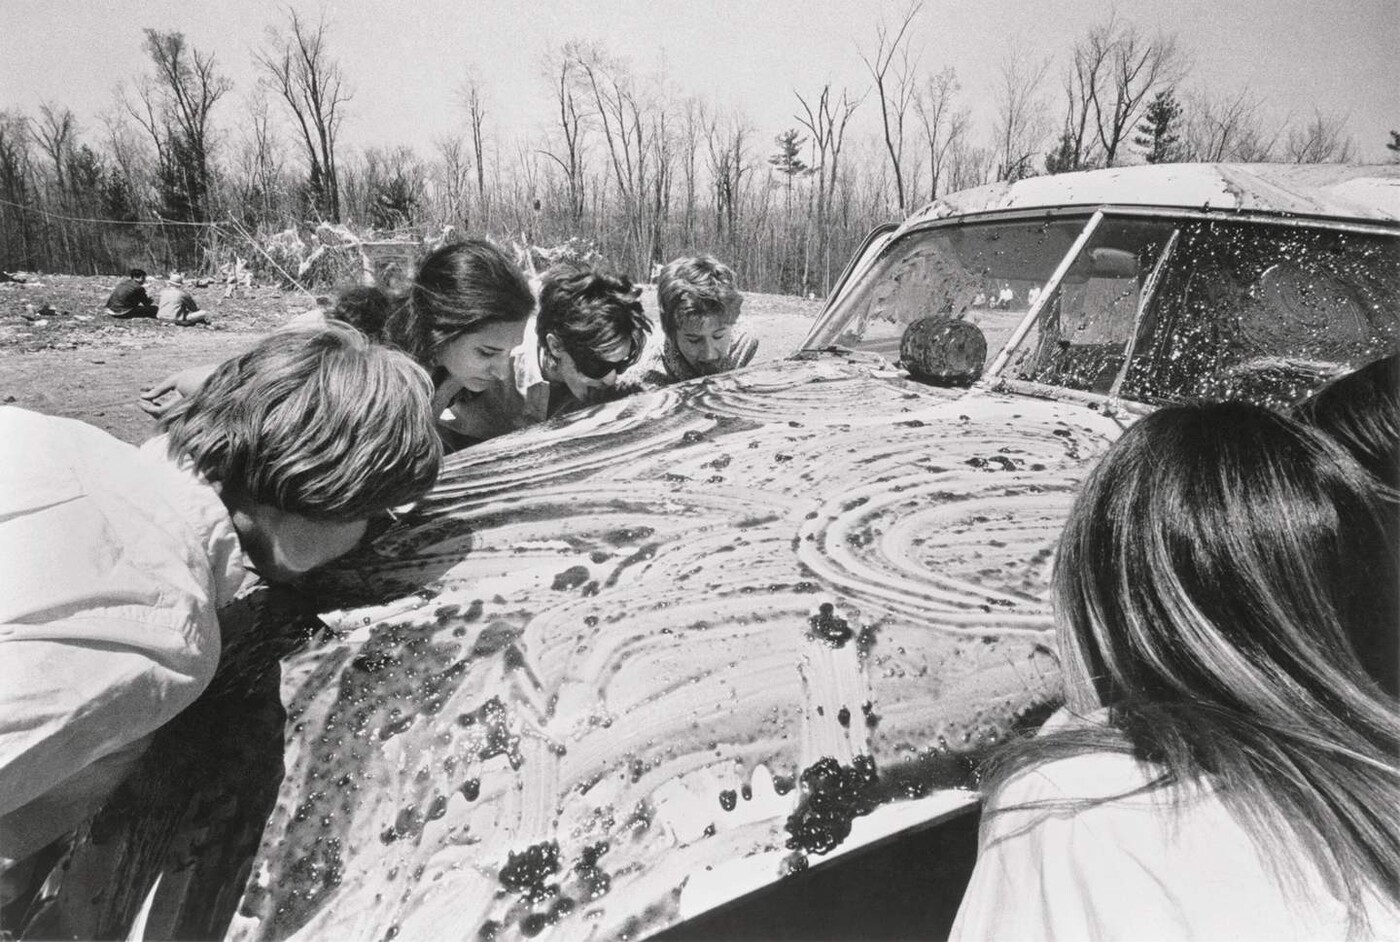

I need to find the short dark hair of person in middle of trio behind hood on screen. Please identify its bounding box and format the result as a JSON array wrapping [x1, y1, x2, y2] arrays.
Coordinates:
[[535, 265, 651, 365]]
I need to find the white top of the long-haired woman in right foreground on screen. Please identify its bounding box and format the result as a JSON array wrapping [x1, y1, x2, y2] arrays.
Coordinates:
[[951, 727, 1400, 942]]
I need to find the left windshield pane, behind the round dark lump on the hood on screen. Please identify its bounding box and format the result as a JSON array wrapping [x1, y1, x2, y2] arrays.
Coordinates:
[[806, 216, 1088, 360]]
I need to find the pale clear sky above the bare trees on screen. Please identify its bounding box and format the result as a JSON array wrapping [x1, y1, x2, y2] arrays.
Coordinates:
[[0, 0, 1400, 161]]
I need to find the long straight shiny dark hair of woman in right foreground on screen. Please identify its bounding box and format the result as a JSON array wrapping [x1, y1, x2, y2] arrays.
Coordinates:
[[988, 403, 1400, 914]]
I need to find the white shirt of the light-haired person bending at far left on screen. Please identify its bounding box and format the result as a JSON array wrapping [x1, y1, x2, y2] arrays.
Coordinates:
[[0, 407, 248, 858]]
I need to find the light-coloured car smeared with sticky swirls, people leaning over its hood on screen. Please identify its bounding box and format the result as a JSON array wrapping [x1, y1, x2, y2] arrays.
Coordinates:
[[31, 164, 1400, 941]]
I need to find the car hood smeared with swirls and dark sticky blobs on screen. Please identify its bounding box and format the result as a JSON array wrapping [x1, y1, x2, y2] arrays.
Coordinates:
[[232, 354, 1120, 939]]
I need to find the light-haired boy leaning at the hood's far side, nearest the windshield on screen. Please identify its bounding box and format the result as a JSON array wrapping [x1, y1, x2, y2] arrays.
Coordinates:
[[641, 255, 759, 385]]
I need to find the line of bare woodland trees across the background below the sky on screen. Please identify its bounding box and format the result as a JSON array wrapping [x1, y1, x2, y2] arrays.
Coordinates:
[[0, 3, 1400, 294]]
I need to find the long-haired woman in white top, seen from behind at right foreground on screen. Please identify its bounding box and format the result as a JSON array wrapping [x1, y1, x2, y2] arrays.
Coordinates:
[[953, 403, 1400, 939]]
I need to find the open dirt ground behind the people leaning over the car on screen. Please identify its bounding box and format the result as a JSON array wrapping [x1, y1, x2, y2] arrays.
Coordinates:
[[0, 274, 822, 442]]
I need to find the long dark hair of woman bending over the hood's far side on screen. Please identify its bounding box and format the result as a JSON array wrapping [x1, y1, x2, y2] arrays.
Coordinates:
[[378, 239, 535, 364]]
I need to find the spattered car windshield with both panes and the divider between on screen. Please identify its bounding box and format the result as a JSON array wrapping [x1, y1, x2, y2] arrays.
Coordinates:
[[806, 214, 1400, 405]]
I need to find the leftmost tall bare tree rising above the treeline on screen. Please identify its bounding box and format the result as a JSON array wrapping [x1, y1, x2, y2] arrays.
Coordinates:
[[127, 29, 232, 223]]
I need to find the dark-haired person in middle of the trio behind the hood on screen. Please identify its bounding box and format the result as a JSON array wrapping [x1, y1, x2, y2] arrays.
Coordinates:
[[484, 265, 651, 428]]
